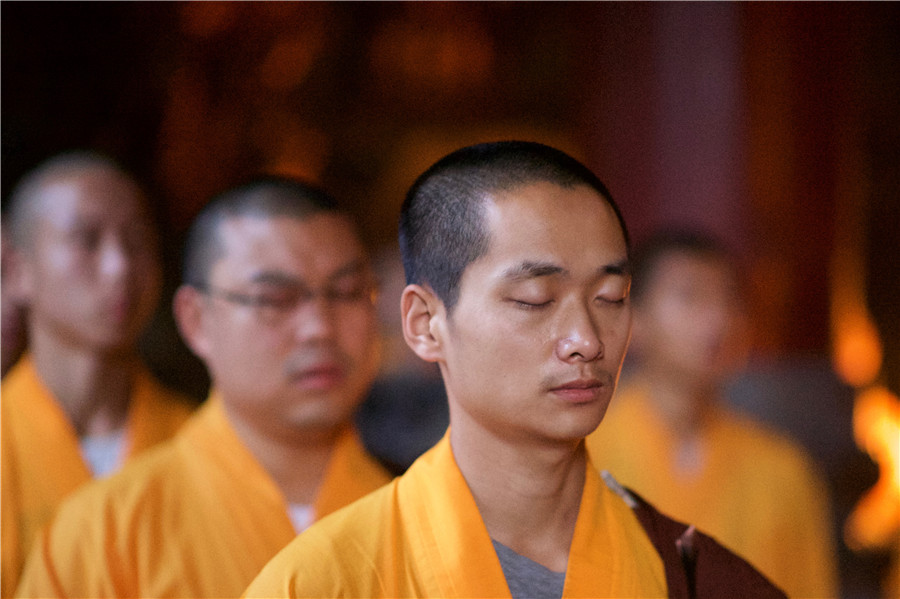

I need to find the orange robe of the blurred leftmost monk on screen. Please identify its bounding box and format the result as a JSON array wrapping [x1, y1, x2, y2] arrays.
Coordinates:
[[0, 354, 193, 597]]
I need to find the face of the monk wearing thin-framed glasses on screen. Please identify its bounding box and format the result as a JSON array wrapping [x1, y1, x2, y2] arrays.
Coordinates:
[[194, 213, 378, 436]]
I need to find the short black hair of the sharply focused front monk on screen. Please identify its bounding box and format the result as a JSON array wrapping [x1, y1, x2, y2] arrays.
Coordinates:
[[400, 141, 629, 311]]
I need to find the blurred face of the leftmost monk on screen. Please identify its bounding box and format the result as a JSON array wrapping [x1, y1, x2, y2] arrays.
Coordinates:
[[22, 169, 161, 352]]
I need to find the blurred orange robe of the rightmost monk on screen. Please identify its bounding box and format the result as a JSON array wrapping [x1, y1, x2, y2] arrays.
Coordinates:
[[586, 381, 838, 598]]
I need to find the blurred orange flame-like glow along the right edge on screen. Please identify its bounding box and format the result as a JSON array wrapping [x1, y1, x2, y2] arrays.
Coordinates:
[[831, 127, 900, 597]]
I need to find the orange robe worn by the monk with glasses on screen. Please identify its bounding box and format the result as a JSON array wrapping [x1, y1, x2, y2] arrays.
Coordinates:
[[17, 394, 390, 597]]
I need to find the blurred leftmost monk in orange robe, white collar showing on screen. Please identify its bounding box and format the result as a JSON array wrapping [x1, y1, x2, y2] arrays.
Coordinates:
[[0, 153, 192, 597]]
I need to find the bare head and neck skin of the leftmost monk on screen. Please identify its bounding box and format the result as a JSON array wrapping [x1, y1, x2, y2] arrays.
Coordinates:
[[4, 166, 161, 436]]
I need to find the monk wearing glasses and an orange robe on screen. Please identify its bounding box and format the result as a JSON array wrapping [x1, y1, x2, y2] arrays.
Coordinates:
[[18, 179, 390, 597]]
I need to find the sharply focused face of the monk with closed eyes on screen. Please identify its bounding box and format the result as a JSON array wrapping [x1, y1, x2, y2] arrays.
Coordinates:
[[438, 182, 631, 442]]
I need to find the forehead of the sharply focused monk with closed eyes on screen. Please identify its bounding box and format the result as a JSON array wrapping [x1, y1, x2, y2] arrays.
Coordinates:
[[484, 182, 628, 272]]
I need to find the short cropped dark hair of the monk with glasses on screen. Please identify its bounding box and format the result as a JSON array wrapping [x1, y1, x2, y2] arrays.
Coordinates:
[[182, 176, 341, 289]]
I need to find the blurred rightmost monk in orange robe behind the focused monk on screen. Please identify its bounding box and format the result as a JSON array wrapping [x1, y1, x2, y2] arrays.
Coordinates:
[[586, 231, 837, 599]]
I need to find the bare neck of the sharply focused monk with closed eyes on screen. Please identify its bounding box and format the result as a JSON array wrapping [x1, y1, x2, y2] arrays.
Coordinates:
[[450, 417, 586, 572]]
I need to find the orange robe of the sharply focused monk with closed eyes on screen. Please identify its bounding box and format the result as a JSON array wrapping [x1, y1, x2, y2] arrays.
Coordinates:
[[245, 436, 666, 598]]
